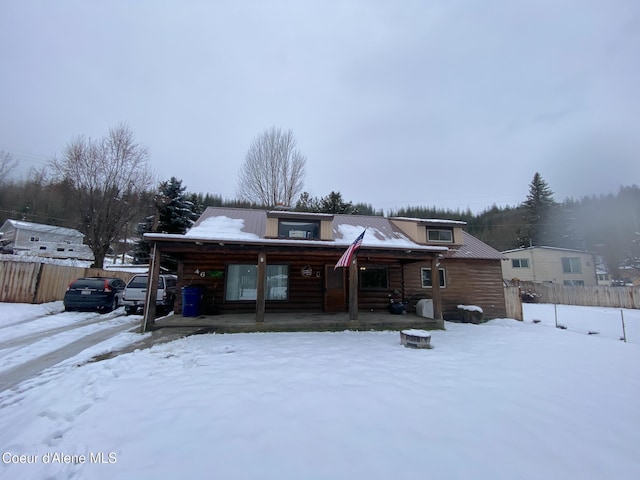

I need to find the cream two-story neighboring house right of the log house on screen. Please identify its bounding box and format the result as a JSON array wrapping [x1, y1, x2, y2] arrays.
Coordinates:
[[502, 247, 598, 286]]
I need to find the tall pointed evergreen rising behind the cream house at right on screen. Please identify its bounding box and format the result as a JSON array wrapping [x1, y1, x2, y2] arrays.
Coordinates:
[[519, 172, 556, 246]]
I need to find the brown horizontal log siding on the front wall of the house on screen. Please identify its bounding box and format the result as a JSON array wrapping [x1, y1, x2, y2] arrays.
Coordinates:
[[175, 251, 506, 318]]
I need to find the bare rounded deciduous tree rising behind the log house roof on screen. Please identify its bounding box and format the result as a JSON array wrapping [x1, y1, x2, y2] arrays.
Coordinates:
[[237, 127, 307, 206]]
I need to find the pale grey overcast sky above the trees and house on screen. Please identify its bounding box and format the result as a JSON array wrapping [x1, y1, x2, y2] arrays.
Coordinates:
[[0, 0, 640, 212]]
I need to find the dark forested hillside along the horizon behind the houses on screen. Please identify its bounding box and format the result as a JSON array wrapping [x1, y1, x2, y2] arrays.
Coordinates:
[[0, 171, 640, 278]]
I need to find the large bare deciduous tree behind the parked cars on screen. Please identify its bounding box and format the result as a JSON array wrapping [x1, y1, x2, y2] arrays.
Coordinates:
[[52, 124, 154, 268]]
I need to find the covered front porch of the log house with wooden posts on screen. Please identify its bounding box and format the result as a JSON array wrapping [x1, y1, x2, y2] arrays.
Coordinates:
[[141, 234, 446, 333]]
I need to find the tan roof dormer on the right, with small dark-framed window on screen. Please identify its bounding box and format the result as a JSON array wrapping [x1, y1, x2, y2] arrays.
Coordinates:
[[390, 217, 466, 247]]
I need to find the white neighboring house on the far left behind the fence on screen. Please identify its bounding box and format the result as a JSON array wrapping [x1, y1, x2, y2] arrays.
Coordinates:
[[0, 219, 93, 260]]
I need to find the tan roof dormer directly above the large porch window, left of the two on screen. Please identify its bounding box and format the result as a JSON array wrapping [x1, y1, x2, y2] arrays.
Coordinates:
[[266, 210, 333, 240]]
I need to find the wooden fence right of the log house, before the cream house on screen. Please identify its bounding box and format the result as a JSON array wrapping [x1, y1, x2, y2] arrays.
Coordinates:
[[509, 282, 640, 308]]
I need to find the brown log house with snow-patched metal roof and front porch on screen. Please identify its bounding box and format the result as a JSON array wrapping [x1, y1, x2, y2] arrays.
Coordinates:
[[145, 207, 506, 321]]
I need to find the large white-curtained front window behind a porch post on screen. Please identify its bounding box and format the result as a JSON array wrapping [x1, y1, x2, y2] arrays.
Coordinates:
[[226, 265, 289, 301]]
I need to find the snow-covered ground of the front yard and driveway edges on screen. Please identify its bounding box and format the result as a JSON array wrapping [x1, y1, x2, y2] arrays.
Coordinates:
[[0, 304, 640, 480]]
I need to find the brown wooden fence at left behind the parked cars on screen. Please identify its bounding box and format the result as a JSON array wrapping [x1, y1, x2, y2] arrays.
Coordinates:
[[0, 260, 133, 303]]
